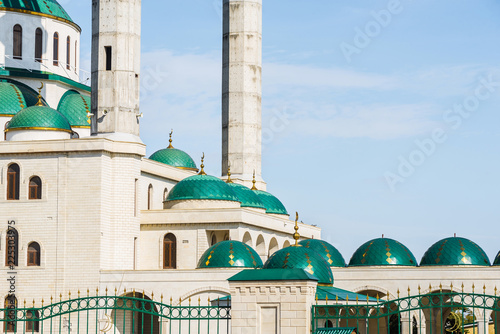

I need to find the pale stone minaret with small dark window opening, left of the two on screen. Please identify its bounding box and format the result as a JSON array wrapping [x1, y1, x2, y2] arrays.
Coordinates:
[[91, 0, 141, 140]]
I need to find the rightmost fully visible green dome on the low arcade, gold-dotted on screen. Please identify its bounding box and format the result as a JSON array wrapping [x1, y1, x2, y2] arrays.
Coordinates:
[[420, 237, 490, 266]]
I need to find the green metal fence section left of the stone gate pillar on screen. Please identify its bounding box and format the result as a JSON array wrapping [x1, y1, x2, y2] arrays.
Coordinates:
[[0, 292, 231, 334]]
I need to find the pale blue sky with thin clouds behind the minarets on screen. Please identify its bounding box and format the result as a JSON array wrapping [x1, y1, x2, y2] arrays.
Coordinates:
[[60, 0, 500, 261]]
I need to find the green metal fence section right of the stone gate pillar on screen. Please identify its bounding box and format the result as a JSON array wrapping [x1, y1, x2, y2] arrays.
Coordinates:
[[311, 289, 500, 334]]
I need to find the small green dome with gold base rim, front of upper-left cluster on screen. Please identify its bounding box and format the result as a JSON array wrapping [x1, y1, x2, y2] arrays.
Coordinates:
[[6, 106, 72, 133]]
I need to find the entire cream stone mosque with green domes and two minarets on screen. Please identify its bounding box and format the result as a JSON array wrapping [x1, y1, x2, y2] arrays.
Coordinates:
[[0, 0, 500, 334]]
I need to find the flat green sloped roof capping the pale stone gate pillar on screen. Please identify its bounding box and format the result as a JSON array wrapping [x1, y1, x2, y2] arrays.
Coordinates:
[[228, 269, 318, 282]]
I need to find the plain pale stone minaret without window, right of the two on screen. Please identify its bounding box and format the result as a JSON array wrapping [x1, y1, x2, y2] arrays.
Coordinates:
[[222, 0, 265, 189]]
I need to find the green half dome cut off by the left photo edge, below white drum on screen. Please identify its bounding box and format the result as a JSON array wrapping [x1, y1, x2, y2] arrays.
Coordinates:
[[0, 79, 46, 116]]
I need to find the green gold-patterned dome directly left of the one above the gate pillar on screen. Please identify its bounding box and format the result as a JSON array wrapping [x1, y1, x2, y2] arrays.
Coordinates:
[[197, 240, 262, 269]]
